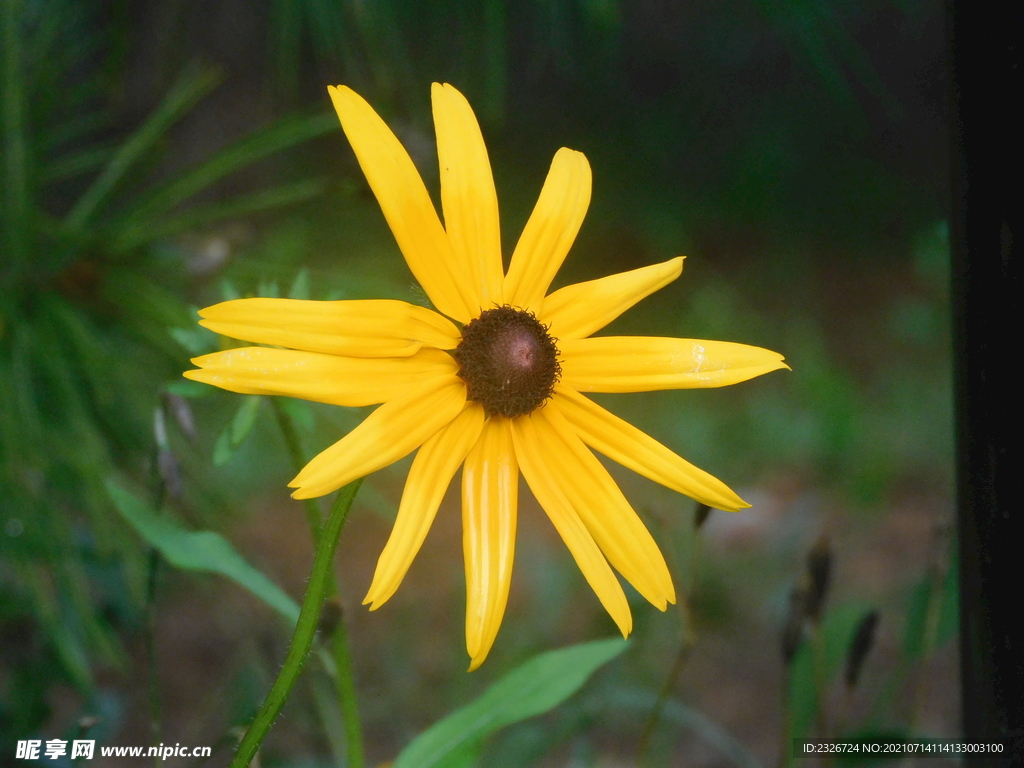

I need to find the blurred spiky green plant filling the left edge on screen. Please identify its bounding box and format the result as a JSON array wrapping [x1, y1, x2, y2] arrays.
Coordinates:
[[0, 0, 334, 750]]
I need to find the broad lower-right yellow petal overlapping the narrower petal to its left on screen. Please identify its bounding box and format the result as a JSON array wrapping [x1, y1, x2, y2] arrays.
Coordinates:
[[532, 402, 676, 610]]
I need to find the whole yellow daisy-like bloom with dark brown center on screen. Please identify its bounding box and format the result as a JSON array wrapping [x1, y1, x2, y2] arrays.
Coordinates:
[[185, 83, 786, 670]]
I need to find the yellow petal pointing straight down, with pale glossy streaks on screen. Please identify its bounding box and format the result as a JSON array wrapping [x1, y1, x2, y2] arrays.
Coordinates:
[[462, 417, 519, 672]]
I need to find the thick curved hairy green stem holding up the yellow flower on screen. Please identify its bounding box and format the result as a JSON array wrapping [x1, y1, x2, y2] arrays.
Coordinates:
[[230, 479, 362, 768]]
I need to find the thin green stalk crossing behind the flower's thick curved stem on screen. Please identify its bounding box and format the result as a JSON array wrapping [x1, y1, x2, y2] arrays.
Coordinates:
[[270, 397, 364, 768]]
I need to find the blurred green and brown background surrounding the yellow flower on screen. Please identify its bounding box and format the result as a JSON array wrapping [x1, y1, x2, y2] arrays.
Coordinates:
[[0, 0, 959, 768]]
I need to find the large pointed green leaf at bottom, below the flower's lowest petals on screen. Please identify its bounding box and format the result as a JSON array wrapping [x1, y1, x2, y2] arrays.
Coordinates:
[[392, 638, 628, 768]]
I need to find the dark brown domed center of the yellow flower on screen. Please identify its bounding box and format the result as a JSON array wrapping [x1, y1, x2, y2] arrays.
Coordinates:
[[454, 306, 561, 419]]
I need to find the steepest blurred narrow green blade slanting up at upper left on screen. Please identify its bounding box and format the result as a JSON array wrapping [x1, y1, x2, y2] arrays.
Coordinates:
[[66, 69, 220, 231]]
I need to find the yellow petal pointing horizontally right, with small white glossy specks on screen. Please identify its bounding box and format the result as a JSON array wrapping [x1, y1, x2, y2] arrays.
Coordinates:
[[558, 336, 788, 392]]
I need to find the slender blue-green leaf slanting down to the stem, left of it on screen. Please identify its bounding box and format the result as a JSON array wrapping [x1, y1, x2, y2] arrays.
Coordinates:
[[106, 480, 299, 624]]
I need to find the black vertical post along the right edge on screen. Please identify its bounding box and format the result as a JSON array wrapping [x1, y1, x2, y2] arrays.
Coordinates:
[[947, 0, 1024, 765]]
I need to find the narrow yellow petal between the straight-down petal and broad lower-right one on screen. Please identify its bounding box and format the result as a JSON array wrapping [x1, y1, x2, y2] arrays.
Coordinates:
[[512, 411, 633, 637]]
